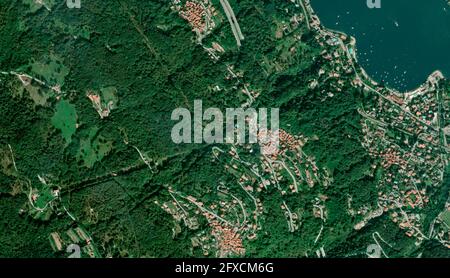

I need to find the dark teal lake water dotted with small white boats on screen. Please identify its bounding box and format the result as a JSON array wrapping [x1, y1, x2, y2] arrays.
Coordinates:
[[311, 0, 450, 91]]
